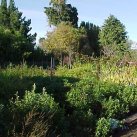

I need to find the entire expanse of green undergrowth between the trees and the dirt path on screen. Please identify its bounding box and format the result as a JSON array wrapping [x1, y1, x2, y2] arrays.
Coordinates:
[[0, 59, 137, 137]]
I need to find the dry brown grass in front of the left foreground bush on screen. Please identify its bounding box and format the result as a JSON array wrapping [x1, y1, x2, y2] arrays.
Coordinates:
[[9, 110, 54, 137]]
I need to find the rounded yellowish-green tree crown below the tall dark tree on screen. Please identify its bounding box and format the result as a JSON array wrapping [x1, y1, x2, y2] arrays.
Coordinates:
[[44, 23, 82, 55]]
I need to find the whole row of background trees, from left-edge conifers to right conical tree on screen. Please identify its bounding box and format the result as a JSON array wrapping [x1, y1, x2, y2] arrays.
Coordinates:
[[0, 0, 129, 64]]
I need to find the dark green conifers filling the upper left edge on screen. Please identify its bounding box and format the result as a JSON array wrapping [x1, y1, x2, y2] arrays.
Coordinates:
[[0, 0, 36, 63]]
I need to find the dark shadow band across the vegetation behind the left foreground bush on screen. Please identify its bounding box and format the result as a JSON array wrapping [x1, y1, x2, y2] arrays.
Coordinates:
[[0, 75, 79, 105]]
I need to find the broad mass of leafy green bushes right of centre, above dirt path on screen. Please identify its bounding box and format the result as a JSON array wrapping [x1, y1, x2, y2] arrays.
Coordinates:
[[67, 78, 137, 136]]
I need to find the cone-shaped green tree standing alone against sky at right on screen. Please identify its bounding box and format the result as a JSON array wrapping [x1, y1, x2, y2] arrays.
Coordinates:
[[99, 15, 128, 52]]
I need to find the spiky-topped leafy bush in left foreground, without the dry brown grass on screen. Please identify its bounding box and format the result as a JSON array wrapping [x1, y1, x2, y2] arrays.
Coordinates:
[[3, 85, 68, 137]]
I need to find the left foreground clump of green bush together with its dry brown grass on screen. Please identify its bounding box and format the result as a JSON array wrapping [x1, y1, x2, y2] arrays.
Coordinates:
[[0, 85, 68, 137]]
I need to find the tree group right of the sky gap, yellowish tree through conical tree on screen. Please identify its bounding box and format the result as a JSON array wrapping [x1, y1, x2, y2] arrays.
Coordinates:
[[42, 0, 130, 61]]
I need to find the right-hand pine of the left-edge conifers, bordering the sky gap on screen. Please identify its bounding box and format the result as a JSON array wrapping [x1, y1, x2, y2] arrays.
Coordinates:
[[8, 0, 36, 60]]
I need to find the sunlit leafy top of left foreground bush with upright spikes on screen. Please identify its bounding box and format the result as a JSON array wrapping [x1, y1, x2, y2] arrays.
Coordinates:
[[11, 84, 58, 113]]
